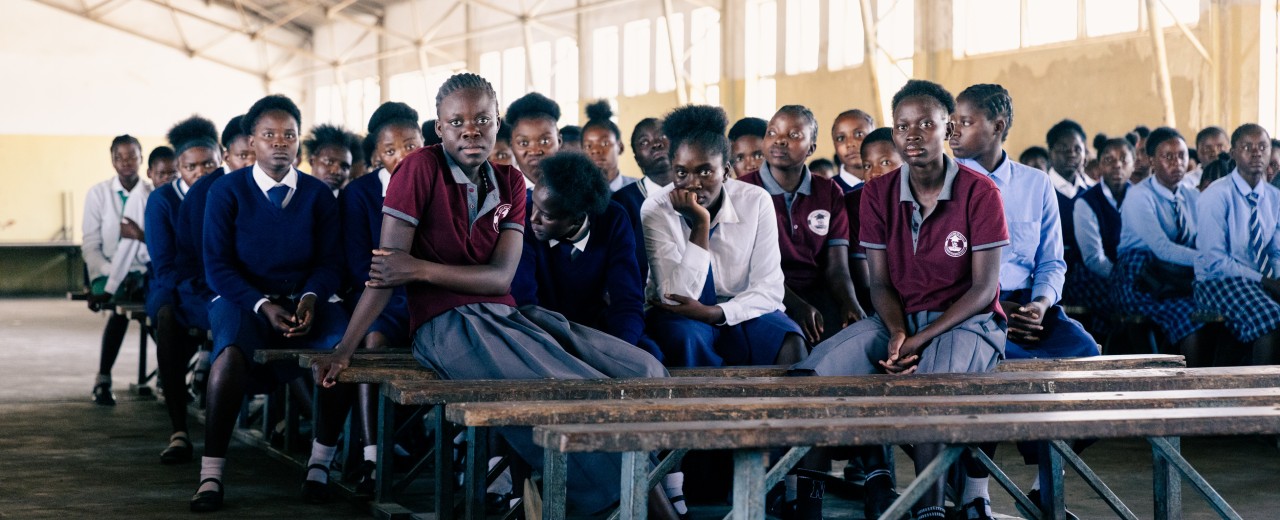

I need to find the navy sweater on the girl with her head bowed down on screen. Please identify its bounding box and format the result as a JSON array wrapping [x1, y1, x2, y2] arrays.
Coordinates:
[[511, 202, 644, 345]]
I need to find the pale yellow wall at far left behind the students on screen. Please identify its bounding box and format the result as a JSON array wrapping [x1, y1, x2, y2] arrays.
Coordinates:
[[0, 134, 163, 243]]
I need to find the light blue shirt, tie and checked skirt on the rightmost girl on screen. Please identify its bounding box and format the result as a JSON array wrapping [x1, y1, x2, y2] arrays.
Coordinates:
[[1194, 169, 1280, 343]]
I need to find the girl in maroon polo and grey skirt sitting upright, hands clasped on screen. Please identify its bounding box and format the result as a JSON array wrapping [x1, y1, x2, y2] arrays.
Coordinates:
[[794, 81, 1009, 519]]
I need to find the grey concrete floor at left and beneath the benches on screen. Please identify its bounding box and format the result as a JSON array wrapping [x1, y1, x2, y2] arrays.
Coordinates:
[[0, 300, 1280, 519]]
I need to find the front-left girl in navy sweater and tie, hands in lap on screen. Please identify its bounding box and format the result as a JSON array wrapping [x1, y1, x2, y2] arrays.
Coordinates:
[[191, 96, 347, 512]]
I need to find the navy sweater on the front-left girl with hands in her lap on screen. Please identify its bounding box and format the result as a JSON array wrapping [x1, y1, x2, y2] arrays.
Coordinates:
[[204, 167, 342, 311]]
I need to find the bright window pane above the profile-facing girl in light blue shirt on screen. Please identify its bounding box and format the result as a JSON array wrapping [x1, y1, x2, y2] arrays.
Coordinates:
[[955, 0, 1021, 55]]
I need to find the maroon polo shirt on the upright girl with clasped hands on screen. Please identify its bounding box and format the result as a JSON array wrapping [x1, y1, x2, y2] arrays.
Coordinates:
[[859, 158, 1009, 315]]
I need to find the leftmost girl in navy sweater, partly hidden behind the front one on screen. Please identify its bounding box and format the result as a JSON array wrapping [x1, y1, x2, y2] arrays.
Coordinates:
[[143, 117, 223, 464]]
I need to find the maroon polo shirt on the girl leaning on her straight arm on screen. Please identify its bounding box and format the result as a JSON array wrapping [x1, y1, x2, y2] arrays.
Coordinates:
[[383, 145, 525, 330]]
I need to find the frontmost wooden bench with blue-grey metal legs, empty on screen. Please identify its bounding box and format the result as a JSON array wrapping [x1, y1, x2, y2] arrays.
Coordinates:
[[534, 405, 1280, 520]]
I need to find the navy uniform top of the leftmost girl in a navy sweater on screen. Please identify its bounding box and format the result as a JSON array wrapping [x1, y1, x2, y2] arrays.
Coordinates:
[[143, 175, 193, 327]]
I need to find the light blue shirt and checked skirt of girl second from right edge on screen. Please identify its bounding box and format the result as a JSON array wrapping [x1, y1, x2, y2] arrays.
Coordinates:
[[1110, 175, 1203, 343]]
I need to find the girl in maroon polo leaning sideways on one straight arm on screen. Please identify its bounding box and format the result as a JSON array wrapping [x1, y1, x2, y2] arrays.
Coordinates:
[[312, 73, 675, 517]]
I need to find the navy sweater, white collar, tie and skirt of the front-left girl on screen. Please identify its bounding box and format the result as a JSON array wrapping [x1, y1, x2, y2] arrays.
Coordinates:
[[204, 164, 348, 371]]
